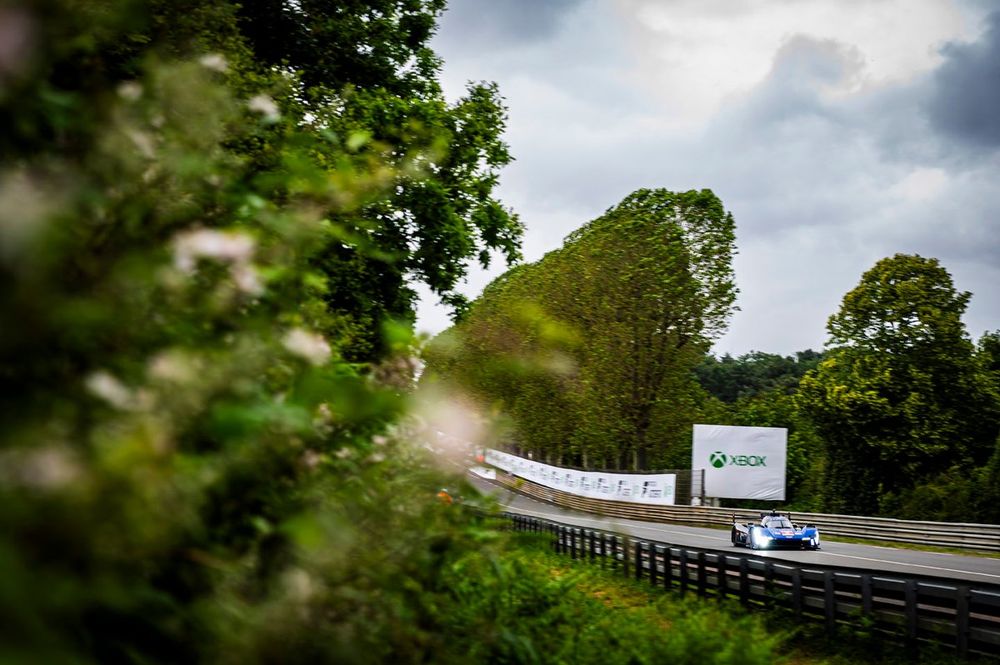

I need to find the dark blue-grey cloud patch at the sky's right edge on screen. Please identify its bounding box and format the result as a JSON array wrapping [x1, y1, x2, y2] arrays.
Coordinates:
[[926, 11, 1000, 149]]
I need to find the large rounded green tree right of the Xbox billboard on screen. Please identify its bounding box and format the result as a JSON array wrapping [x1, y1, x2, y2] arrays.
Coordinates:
[[799, 254, 995, 514]]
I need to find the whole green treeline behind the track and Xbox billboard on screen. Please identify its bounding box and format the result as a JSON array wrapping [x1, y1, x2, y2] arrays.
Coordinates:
[[426, 200, 1000, 522]]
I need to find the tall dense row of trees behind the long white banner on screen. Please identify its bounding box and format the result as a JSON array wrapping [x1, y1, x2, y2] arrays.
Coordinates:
[[426, 189, 736, 469]]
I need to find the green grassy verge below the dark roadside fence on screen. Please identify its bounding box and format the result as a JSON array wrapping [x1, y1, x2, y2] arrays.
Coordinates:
[[448, 534, 995, 665]]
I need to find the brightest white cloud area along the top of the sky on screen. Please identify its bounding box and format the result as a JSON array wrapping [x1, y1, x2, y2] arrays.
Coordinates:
[[617, 0, 964, 122]]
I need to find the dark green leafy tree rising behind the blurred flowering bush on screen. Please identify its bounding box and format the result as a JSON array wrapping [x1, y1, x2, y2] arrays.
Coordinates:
[[229, 0, 522, 360]]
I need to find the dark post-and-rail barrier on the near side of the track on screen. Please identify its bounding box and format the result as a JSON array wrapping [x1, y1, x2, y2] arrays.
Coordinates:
[[503, 513, 1000, 657]]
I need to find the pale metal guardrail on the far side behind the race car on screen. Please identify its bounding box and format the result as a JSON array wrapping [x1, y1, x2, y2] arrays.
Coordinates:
[[484, 470, 1000, 552]]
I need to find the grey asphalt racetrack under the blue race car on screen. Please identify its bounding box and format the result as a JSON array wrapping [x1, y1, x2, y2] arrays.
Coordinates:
[[469, 475, 1000, 587]]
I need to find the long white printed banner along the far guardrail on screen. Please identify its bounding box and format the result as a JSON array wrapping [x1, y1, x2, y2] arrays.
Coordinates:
[[486, 449, 677, 506]]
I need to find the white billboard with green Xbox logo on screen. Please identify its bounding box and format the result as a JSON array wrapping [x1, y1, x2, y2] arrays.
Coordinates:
[[691, 425, 788, 501]]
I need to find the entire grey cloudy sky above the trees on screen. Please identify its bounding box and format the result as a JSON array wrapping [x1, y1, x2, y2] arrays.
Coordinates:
[[410, 0, 1000, 354]]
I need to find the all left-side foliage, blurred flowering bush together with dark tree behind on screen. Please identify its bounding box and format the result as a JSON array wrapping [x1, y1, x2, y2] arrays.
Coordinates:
[[0, 0, 532, 663]]
